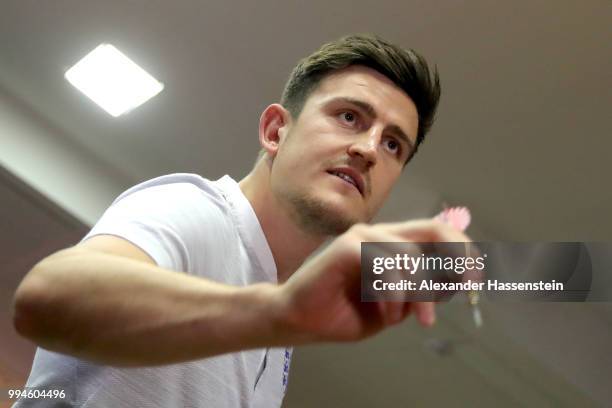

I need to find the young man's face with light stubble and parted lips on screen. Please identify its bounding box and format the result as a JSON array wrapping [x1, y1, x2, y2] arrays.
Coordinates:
[[271, 66, 418, 235]]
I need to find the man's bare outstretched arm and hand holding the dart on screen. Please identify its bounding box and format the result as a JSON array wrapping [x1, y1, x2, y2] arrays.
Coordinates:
[[14, 220, 468, 366]]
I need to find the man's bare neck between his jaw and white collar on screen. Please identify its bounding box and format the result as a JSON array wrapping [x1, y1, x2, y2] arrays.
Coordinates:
[[239, 159, 327, 283]]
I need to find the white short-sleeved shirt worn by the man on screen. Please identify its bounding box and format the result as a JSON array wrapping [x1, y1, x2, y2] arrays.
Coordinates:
[[15, 173, 292, 408]]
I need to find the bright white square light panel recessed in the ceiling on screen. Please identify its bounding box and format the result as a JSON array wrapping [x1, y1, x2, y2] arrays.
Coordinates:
[[65, 44, 164, 117]]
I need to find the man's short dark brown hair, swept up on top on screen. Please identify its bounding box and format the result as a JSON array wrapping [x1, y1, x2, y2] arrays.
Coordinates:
[[281, 34, 440, 161]]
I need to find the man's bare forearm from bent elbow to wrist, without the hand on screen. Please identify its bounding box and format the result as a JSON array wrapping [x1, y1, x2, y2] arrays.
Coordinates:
[[15, 250, 289, 366]]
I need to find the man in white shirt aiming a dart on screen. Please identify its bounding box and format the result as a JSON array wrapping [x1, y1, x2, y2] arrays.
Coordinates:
[[14, 36, 467, 407]]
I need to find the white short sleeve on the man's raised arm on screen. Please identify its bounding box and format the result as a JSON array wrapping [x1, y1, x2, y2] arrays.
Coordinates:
[[81, 183, 222, 272]]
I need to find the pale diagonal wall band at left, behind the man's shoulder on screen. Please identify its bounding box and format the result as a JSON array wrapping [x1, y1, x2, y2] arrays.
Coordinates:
[[0, 92, 133, 226]]
